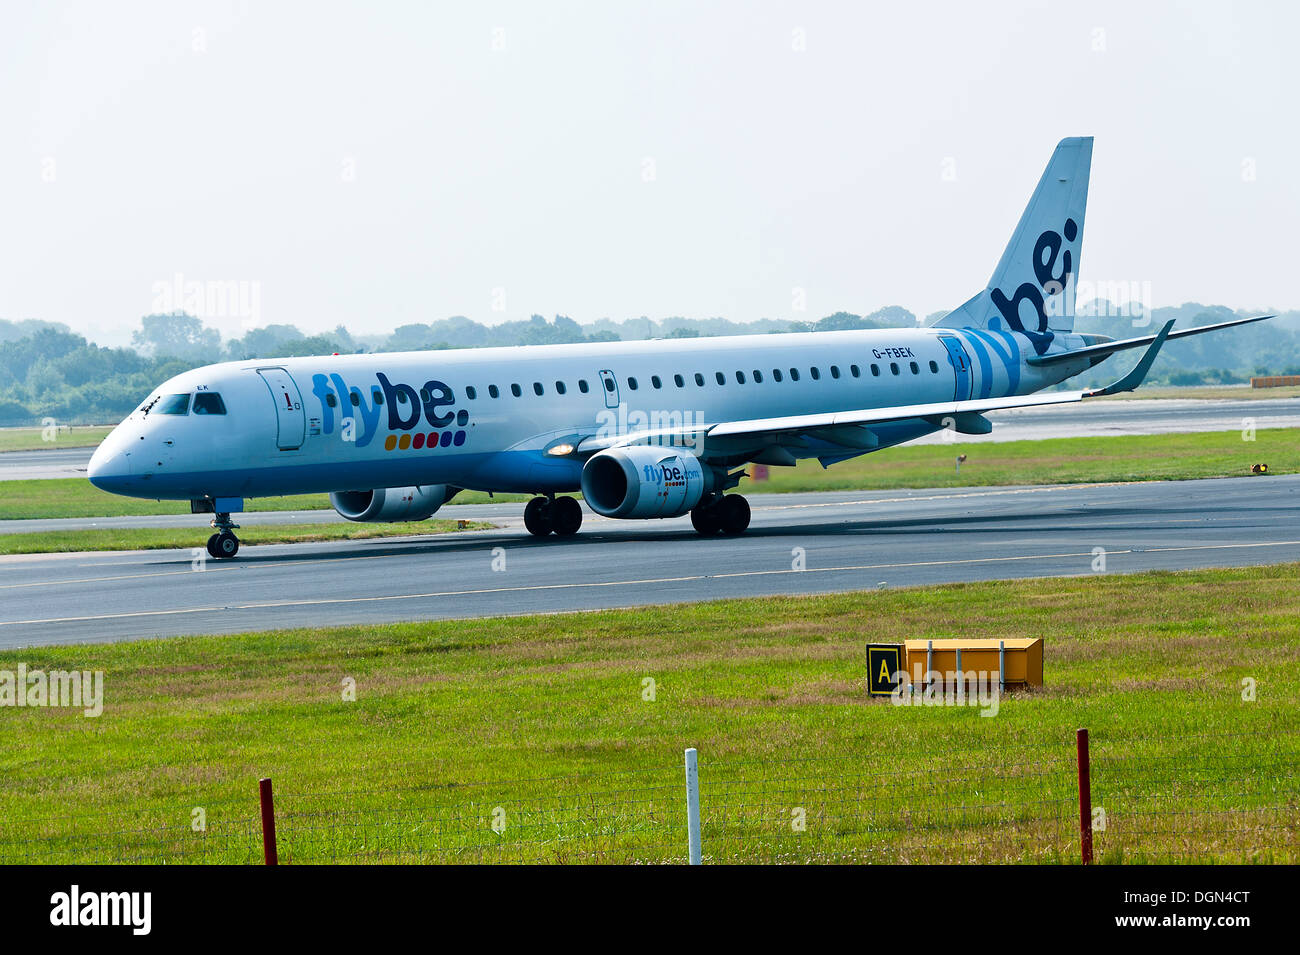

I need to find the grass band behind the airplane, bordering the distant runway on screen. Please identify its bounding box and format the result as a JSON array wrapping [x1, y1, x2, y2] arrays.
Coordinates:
[[0, 429, 1300, 521]]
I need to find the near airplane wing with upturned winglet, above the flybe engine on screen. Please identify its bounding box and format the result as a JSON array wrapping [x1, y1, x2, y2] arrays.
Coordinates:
[[576, 321, 1174, 455]]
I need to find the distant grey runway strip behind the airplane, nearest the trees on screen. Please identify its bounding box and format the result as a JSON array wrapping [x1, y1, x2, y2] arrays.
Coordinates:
[[0, 398, 1300, 481]]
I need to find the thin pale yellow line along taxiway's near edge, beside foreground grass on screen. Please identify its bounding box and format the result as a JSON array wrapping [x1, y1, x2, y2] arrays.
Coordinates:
[[0, 541, 1300, 626]]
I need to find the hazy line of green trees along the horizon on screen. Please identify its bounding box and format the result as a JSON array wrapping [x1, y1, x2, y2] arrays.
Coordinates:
[[0, 303, 1300, 427]]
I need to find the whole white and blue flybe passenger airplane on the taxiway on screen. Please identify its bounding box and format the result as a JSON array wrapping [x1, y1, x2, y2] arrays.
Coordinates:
[[87, 136, 1273, 559]]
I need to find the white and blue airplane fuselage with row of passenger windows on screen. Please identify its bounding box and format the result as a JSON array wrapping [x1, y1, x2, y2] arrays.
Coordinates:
[[90, 329, 1087, 499]]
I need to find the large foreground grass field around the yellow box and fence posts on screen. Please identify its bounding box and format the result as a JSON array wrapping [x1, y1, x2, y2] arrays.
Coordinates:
[[0, 565, 1300, 861]]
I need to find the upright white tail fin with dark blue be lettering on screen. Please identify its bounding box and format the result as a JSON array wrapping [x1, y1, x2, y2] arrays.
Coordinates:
[[935, 136, 1092, 355]]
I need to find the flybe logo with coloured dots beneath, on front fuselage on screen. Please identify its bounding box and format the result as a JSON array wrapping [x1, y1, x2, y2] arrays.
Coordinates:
[[312, 372, 469, 451]]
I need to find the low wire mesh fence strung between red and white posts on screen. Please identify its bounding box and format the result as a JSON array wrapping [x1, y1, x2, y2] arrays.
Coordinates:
[[0, 729, 1300, 864]]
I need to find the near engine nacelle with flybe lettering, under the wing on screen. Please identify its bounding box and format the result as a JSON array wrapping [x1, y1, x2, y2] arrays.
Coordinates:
[[582, 444, 714, 518]]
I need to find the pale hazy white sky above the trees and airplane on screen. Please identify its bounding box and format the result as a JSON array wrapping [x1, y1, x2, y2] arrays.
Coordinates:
[[0, 0, 1300, 343]]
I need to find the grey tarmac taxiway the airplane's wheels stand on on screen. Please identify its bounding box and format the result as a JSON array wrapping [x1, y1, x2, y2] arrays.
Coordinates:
[[0, 476, 1300, 647]]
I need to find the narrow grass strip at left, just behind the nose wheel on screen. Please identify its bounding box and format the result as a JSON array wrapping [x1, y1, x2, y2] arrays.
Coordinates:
[[0, 520, 494, 556]]
